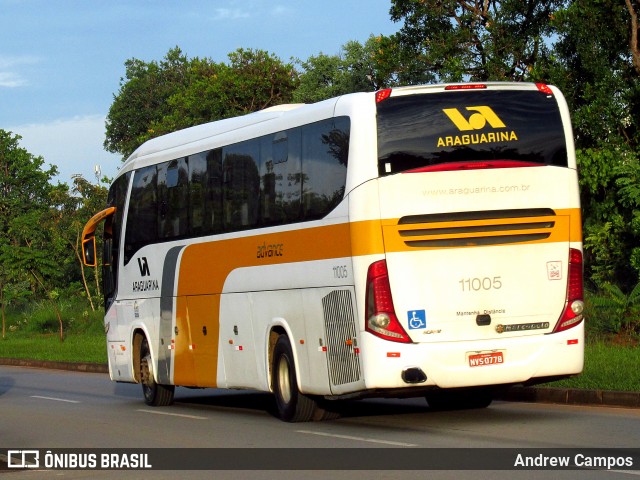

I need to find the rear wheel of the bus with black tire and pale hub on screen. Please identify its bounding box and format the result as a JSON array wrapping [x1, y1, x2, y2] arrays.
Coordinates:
[[271, 335, 324, 422]]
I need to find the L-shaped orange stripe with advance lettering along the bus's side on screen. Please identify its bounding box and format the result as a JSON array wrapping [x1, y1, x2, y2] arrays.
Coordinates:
[[174, 223, 362, 387]]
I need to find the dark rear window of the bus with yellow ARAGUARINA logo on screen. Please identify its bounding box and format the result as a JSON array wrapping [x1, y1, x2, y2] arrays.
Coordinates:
[[377, 90, 567, 176]]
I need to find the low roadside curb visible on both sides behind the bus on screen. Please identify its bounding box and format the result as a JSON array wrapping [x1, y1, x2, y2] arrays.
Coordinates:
[[0, 358, 640, 408]]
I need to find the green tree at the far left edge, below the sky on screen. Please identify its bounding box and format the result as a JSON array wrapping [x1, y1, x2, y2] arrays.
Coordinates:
[[0, 130, 64, 340]]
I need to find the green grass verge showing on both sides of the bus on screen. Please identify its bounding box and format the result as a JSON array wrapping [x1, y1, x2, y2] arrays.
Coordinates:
[[0, 297, 640, 392]]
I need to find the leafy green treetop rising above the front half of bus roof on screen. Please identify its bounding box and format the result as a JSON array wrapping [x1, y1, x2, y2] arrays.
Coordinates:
[[104, 47, 297, 157]]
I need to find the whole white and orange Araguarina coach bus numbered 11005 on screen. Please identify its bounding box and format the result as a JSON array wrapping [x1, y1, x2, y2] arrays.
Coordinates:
[[83, 83, 584, 421]]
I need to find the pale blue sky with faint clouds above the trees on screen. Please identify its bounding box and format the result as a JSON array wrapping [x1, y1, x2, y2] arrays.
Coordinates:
[[0, 0, 400, 183]]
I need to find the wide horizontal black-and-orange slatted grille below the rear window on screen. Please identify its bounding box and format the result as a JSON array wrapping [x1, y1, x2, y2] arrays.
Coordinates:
[[398, 208, 556, 248]]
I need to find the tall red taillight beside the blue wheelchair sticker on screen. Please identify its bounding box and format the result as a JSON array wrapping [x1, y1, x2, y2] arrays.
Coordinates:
[[365, 260, 411, 343]]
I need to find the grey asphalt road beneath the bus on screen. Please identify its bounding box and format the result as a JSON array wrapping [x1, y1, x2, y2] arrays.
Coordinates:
[[0, 366, 640, 480]]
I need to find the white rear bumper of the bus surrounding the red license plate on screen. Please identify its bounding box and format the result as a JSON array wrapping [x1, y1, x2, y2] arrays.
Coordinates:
[[361, 322, 584, 390]]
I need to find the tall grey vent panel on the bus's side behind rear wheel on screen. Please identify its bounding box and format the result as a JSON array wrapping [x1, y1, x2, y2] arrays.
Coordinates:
[[322, 290, 360, 385]]
